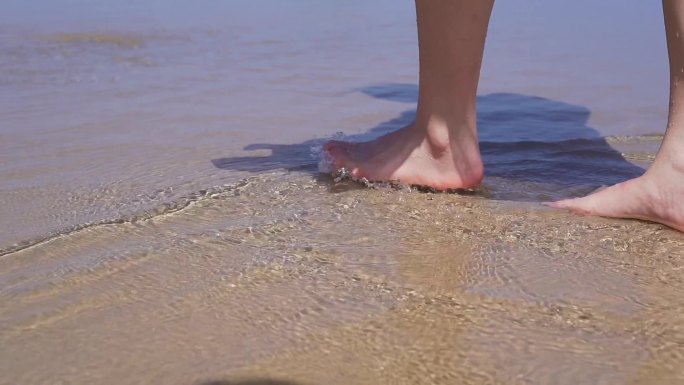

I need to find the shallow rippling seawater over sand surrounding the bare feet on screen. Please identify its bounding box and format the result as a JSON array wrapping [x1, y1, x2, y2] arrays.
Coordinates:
[[0, 0, 684, 384]]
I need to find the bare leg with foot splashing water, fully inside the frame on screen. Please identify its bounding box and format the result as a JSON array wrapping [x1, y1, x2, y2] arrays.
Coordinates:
[[325, 0, 494, 190]]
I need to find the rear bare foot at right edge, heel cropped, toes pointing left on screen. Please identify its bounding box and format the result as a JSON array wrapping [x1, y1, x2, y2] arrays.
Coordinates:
[[550, 160, 684, 231]]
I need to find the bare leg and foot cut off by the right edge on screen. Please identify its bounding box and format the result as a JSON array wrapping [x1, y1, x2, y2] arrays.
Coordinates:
[[552, 0, 684, 231]]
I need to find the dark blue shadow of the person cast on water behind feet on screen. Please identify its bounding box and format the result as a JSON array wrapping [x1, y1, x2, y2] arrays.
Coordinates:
[[212, 84, 644, 200]]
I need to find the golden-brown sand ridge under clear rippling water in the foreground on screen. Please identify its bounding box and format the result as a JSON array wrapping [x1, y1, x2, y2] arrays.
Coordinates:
[[0, 173, 684, 384]]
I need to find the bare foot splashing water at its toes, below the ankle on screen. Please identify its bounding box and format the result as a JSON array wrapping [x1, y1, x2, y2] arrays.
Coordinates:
[[324, 123, 484, 190]]
